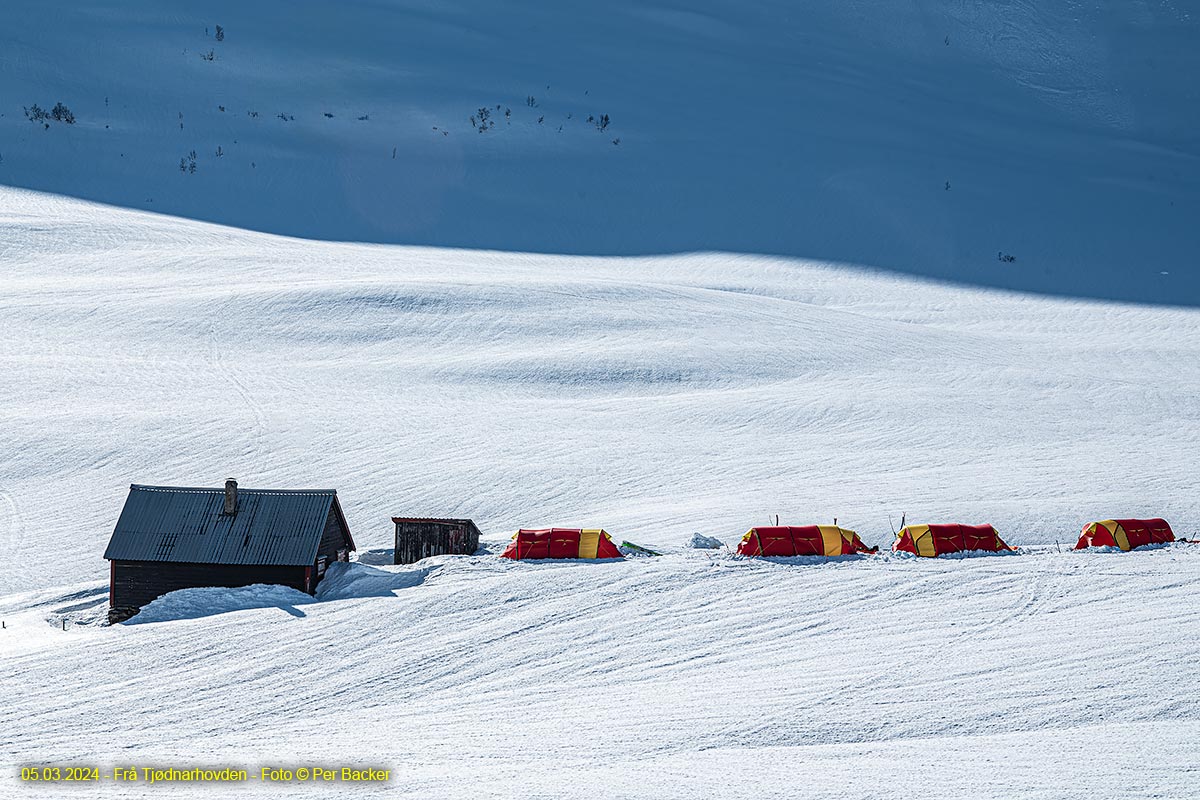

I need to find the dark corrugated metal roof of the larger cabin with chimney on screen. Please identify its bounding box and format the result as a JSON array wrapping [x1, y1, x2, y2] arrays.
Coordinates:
[[104, 483, 353, 566]]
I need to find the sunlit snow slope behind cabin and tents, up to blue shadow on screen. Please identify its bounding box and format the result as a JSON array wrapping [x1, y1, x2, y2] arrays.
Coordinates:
[[0, 184, 1200, 591]]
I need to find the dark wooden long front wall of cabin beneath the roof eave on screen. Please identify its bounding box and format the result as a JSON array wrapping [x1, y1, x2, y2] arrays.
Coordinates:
[[109, 561, 307, 608]]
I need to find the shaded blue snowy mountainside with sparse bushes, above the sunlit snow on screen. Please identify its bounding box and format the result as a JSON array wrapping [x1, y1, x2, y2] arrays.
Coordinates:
[[0, 0, 1200, 305]]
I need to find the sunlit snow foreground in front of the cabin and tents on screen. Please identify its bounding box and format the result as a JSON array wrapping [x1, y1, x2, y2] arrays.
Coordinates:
[[7, 545, 1200, 800]]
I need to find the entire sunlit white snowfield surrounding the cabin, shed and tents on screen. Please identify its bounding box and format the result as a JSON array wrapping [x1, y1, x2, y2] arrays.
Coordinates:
[[0, 188, 1200, 799]]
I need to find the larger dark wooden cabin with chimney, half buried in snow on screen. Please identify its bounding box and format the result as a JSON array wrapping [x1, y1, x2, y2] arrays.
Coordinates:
[[104, 479, 354, 622]]
